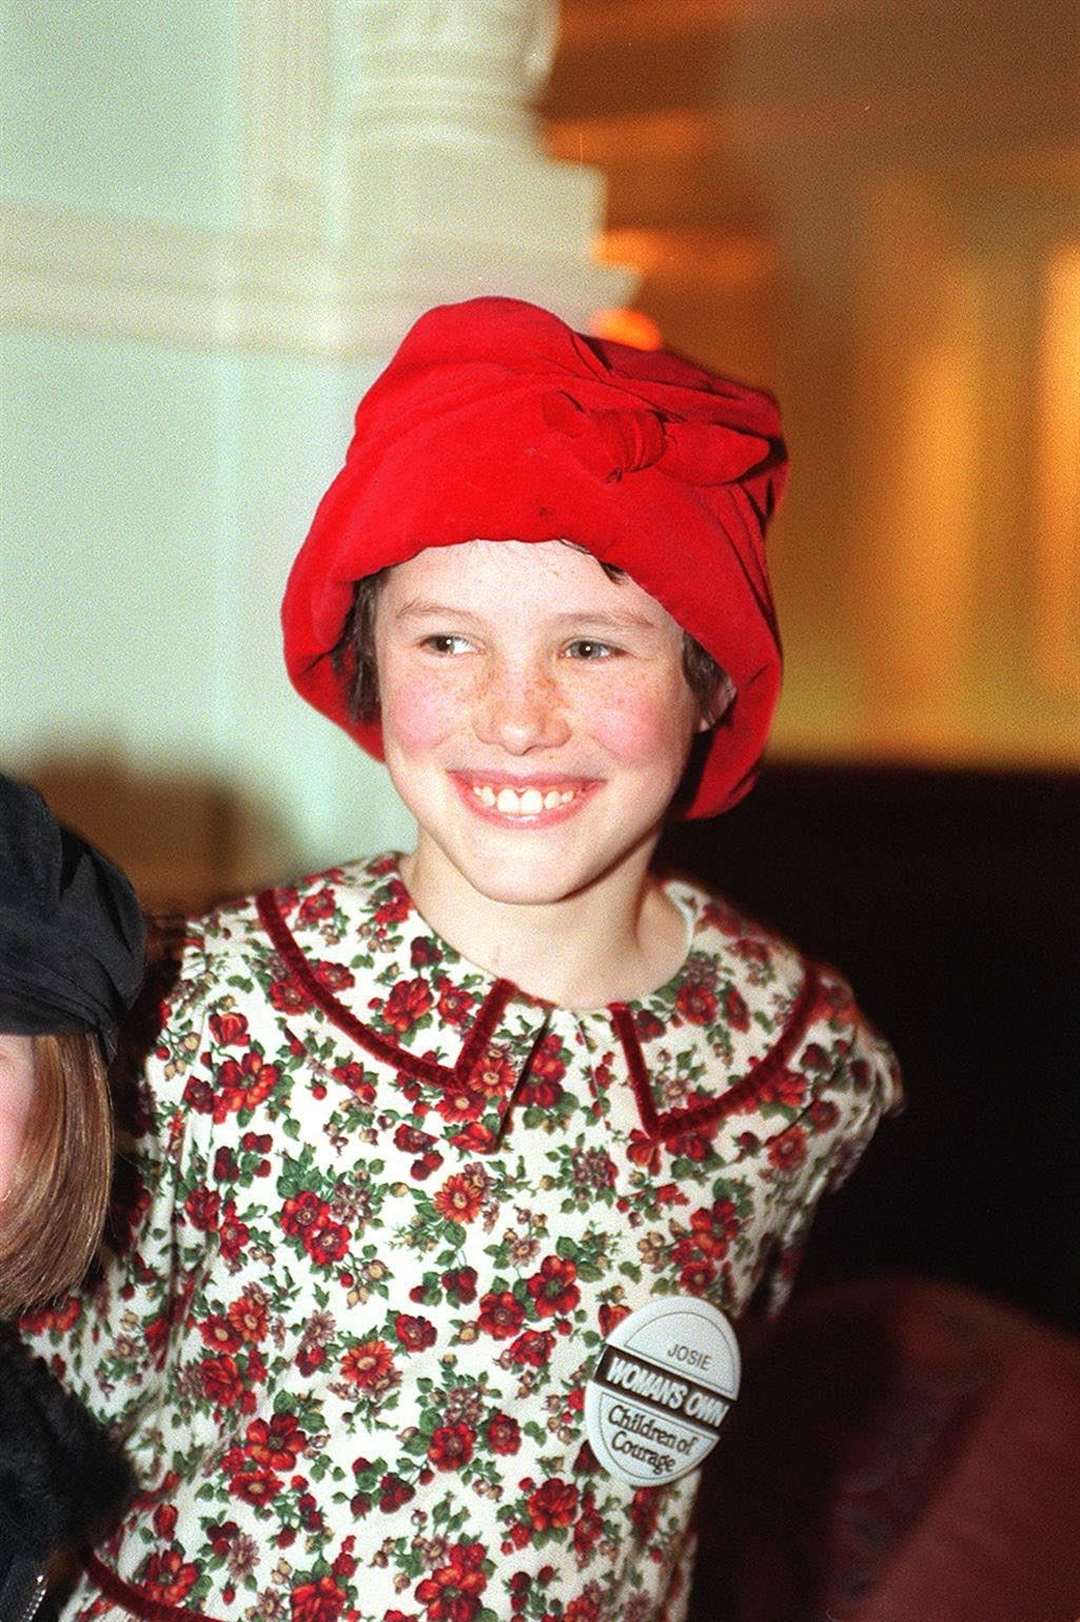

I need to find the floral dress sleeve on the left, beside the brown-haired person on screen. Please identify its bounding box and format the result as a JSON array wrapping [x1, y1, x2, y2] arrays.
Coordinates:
[[19, 934, 211, 1474]]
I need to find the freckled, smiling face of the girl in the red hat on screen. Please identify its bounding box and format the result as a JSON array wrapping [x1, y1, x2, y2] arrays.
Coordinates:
[[375, 540, 705, 903]]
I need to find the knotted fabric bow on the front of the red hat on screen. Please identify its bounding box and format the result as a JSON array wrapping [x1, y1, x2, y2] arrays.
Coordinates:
[[540, 389, 769, 485]]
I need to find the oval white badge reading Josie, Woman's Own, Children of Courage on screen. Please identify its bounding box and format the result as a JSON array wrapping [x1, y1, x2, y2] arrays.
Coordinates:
[[585, 1296, 739, 1487]]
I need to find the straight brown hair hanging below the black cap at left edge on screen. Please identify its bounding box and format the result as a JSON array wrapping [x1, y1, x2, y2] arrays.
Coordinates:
[[0, 1030, 112, 1317]]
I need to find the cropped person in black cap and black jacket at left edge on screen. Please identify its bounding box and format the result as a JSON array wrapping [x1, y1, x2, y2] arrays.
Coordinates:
[[0, 777, 144, 1622]]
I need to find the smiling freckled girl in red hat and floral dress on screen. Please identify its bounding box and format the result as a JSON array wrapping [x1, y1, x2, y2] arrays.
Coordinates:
[[21, 298, 898, 1622]]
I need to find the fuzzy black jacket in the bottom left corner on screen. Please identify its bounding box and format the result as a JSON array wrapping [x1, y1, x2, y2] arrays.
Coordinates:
[[0, 1325, 131, 1622]]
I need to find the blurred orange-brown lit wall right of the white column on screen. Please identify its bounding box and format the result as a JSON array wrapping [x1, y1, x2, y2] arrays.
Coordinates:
[[545, 0, 1080, 766]]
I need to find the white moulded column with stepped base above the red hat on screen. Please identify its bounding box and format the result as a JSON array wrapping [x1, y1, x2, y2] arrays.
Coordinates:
[[345, 0, 636, 324]]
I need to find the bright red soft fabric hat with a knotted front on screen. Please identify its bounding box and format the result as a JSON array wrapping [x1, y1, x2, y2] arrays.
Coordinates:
[[282, 298, 786, 816]]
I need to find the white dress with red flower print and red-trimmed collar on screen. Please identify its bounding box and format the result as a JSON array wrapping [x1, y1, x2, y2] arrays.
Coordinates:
[[24, 855, 898, 1622]]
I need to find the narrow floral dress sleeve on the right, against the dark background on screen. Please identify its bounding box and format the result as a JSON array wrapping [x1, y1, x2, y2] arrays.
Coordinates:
[[755, 970, 903, 1317]]
